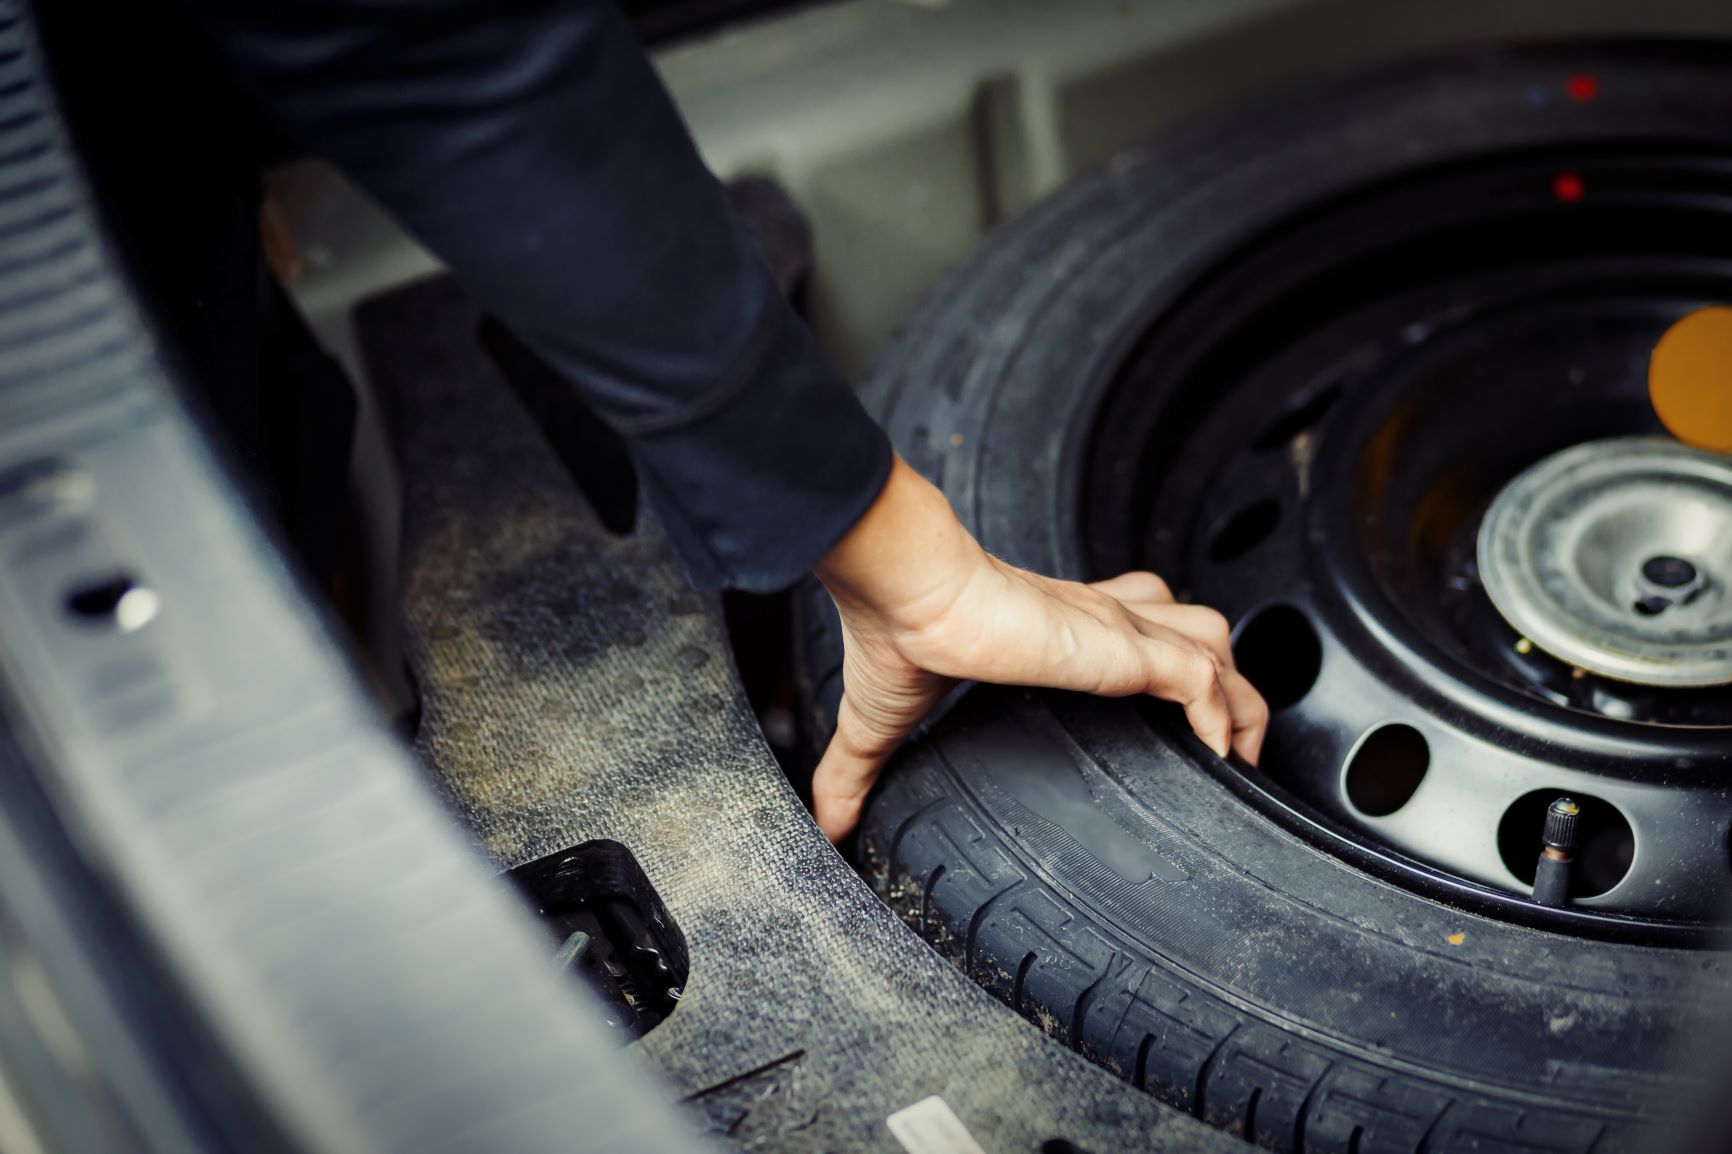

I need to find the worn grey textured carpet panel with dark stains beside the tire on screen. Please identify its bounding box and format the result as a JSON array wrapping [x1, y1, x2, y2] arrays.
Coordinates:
[[360, 281, 1245, 1154]]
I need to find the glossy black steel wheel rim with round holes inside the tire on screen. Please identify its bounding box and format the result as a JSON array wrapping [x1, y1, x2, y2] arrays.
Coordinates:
[[1084, 139, 1732, 932]]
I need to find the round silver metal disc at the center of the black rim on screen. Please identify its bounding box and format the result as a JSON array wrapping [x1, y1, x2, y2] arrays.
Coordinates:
[[1477, 437, 1732, 686]]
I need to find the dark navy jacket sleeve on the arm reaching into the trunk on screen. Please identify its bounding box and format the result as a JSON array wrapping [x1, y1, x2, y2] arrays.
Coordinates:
[[191, 0, 890, 589]]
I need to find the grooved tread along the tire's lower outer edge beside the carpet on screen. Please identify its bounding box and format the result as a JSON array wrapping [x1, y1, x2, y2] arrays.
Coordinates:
[[863, 761, 1635, 1154]]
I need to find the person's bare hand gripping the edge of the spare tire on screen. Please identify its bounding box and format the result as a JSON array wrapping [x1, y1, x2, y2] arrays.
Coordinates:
[[812, 457, 1270, 840]]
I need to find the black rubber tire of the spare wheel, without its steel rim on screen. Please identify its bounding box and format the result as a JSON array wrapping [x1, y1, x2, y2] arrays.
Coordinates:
[[800, 45, 1732, 1154]]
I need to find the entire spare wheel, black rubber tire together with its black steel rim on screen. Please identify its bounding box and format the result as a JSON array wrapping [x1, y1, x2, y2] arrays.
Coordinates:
[[804, 45, 1732, 1151]]
